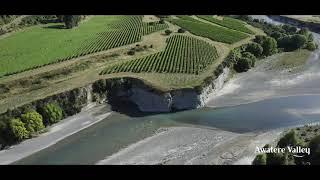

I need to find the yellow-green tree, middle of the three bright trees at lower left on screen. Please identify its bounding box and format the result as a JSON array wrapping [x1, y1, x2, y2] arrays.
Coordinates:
[[21, 110, 44, 134]]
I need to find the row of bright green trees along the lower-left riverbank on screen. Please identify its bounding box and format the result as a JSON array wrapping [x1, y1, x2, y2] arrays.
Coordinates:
[[0, 103, 63, 141]]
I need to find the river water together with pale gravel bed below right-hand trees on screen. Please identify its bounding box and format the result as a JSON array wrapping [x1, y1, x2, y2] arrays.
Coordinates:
[[14, 16, 320, 164]]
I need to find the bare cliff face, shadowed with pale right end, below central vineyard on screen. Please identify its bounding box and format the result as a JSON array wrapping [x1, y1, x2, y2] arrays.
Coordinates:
[[112, 68, 230, 112]]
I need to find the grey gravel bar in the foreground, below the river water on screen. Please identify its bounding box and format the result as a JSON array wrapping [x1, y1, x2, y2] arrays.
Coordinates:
[[97, 127, 281, 165]]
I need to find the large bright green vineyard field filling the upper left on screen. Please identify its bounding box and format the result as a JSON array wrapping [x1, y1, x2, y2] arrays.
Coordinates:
[[0, 16, 168, 77]]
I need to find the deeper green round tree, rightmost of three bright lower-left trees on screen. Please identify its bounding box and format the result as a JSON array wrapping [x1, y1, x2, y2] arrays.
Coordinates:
[[41, 103, 63, 124]]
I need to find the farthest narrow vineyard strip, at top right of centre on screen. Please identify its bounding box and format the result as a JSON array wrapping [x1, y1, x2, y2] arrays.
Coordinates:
[[197, 15, 254, 34]]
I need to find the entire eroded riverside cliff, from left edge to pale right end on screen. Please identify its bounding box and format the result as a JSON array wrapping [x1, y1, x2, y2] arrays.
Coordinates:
[[0, 67, 230, 116]]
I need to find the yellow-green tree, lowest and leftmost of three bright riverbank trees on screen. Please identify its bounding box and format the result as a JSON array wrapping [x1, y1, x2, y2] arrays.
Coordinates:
[[9, 118, 30, 141]]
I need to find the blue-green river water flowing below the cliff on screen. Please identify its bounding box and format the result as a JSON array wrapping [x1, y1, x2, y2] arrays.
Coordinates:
[[14, 95, 320, 164]]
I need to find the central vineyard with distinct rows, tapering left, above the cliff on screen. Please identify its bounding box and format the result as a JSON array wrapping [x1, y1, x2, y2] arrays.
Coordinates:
[[101, 35, 218, 74]]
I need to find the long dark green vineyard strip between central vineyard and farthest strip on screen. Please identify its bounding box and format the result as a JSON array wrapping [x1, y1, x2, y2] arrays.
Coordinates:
[[169, 16, 249, 44]]
